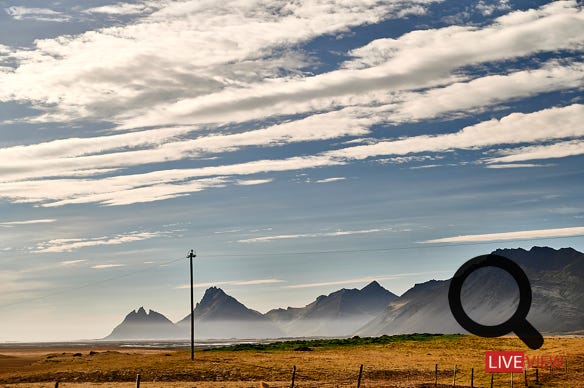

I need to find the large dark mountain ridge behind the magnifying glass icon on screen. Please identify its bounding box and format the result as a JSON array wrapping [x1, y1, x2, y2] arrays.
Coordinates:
[[356, 247, 584, 335]]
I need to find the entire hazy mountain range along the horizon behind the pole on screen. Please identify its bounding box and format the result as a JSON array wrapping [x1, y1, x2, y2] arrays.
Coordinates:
[[105, 247, 584, 340]]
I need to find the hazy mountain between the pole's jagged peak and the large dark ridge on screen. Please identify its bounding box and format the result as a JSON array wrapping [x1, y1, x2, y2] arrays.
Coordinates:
[[266, 281, 397, 337]]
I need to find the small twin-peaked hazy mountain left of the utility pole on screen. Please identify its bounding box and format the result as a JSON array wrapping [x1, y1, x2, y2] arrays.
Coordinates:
[[104, 307, 179, 340]]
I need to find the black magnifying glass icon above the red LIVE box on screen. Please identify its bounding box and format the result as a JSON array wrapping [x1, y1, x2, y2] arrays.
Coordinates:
[[448, 254, 543, 350]]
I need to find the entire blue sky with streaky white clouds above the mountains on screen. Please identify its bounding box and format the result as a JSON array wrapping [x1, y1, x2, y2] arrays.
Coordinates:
[[0, 0, 584, 342]]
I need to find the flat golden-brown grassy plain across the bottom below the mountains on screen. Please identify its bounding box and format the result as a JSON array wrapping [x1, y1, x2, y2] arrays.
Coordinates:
[[0, 335, 584, 388]]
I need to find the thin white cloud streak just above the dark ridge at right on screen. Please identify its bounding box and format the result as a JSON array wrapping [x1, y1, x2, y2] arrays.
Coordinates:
[[423, 226, 584, 244]]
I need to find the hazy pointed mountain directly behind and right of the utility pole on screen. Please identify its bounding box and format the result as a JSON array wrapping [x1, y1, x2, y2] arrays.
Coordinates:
[[177, 287, 284, 339]]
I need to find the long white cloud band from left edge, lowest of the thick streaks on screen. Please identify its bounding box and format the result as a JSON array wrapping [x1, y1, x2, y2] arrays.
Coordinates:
[[0, 156, 344, 206]]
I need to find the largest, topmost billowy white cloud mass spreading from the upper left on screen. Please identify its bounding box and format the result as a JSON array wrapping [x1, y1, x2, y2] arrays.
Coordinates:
[[0, 1, 582, 131]]
